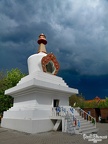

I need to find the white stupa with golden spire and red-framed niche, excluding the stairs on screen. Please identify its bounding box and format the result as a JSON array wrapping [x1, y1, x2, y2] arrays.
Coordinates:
[[1, 34, 78, 133]]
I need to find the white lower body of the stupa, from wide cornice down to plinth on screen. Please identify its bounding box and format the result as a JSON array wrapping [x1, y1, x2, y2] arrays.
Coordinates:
[[1, 76, 78, 133]]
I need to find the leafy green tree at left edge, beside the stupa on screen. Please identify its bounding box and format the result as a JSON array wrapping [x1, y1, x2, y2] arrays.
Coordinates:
[[0, 68, 25, 114]]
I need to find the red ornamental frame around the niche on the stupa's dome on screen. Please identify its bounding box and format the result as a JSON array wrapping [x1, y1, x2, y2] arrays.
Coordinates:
[[41, 53, 60, 75]]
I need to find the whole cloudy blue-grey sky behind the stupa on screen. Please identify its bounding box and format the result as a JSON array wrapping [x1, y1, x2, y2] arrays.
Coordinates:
[[0, 0, 108, 99]]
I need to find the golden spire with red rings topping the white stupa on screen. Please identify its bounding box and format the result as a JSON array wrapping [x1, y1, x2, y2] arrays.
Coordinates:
[[37, 33, 47, 53]]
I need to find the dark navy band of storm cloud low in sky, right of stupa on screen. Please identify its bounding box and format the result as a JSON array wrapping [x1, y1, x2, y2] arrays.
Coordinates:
[[59, 69, 108, 99]]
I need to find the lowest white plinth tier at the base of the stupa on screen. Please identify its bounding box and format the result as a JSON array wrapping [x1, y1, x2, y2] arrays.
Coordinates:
[[2, 118, 54, 134]]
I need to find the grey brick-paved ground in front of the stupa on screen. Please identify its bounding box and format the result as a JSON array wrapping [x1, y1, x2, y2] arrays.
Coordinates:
[[0, 123, 108, 144]]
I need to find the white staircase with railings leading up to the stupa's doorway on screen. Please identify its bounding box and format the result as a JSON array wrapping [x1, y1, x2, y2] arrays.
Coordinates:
[[53, 107, 98, 134]]
